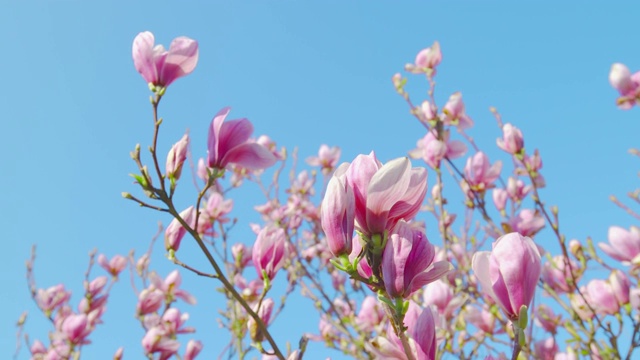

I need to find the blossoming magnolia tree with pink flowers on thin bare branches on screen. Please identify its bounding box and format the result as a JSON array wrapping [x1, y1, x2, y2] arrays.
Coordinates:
[[13, 32, 640, 360]]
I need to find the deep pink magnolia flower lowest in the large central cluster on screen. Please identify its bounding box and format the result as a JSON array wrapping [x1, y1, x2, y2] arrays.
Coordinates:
[[382, 220, 451, 298]]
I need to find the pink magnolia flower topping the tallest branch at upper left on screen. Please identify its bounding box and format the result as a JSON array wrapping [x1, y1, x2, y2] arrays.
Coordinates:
[[132, 31, 198, 87]]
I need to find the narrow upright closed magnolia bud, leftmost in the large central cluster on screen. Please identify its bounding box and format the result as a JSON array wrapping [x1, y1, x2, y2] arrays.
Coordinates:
[[320, 175, 356, 256]]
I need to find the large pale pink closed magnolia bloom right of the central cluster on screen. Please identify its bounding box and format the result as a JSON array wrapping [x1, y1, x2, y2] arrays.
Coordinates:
[[472, 233, 542, 320]]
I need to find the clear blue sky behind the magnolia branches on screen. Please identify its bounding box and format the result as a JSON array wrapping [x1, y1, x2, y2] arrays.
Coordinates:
[[0, 1, 640, 358]]
